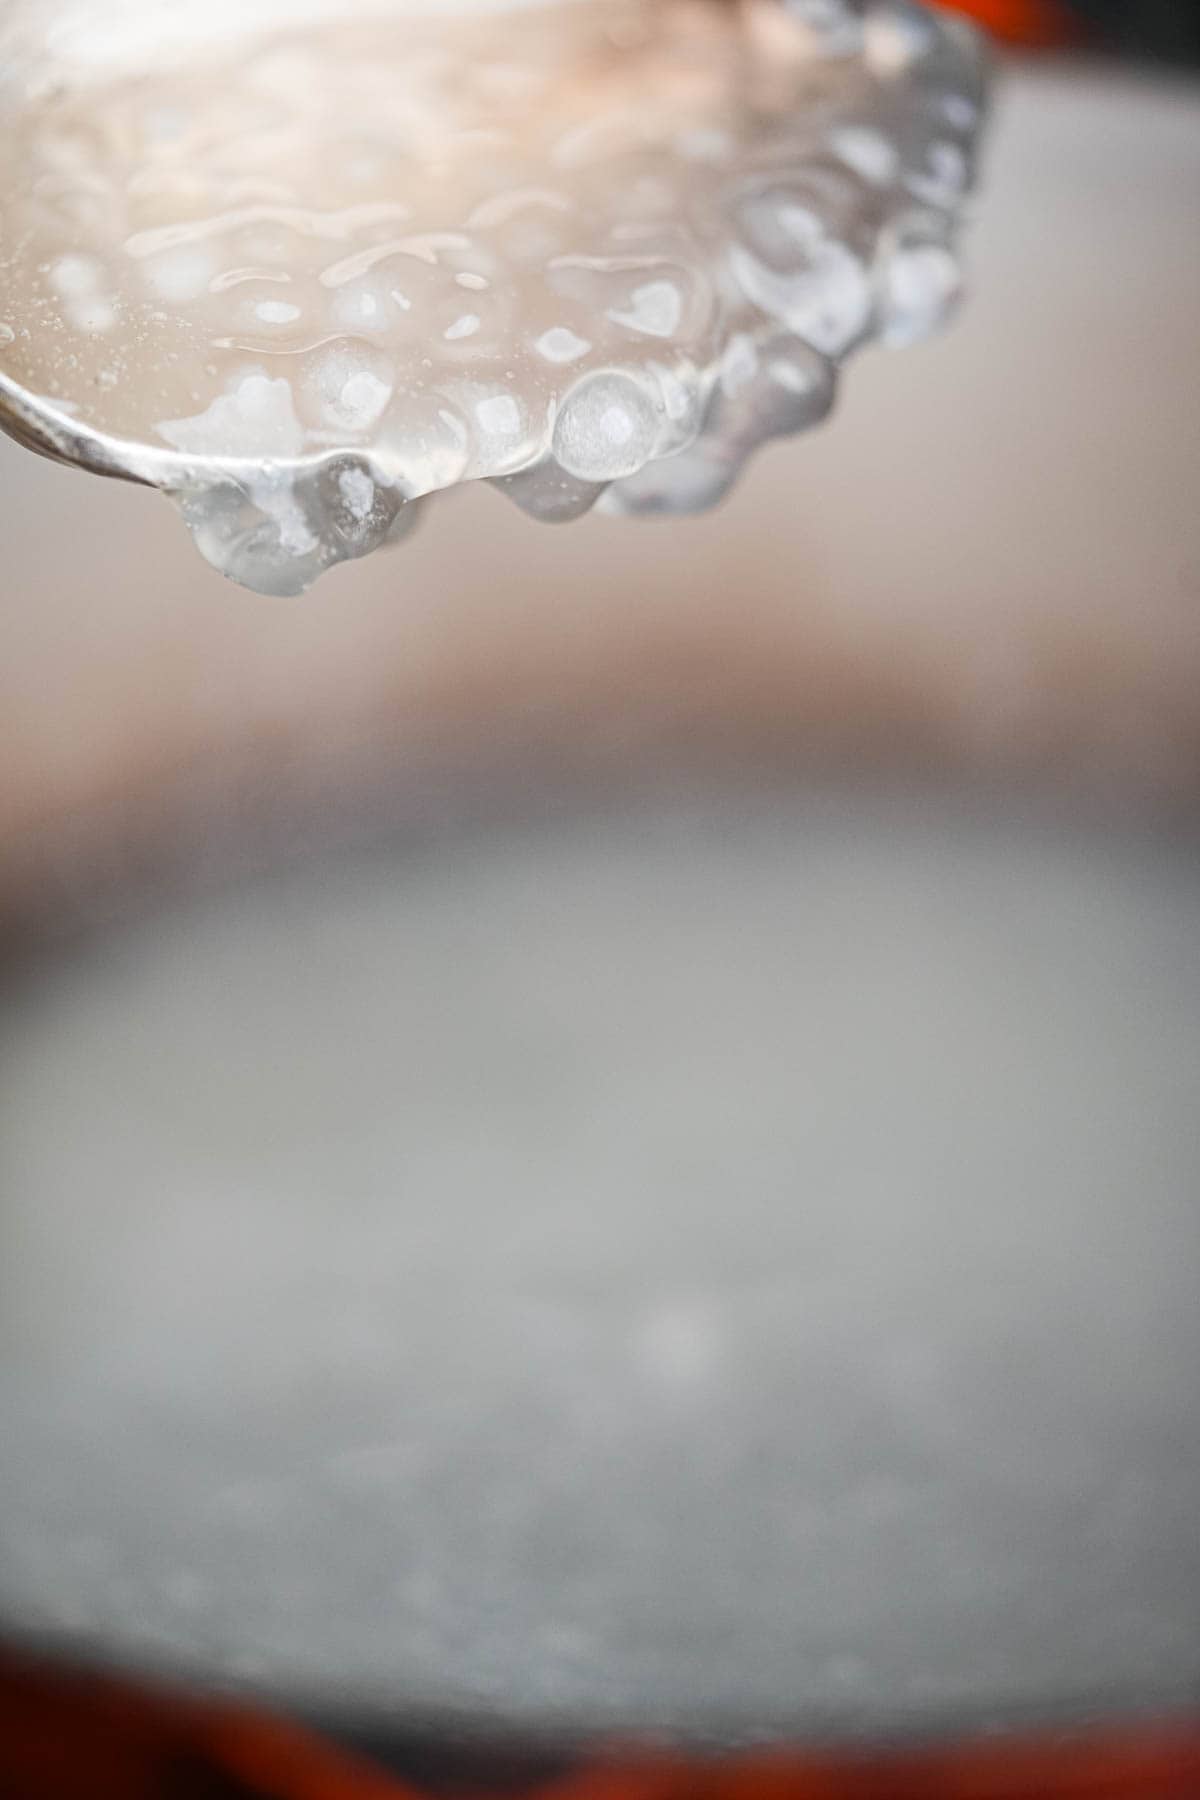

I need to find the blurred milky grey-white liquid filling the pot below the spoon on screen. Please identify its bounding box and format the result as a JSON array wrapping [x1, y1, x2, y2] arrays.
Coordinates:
[[0, 792, 1200, 1733]]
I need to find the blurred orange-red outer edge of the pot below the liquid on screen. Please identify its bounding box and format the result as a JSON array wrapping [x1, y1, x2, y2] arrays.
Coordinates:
[[0, 1654, 1200, 1800]]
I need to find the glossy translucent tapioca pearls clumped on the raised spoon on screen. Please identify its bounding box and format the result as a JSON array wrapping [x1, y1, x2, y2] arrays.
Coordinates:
[[0, 0, 981, 594]]
